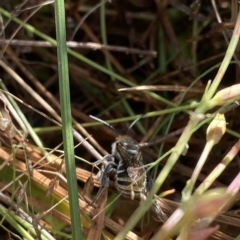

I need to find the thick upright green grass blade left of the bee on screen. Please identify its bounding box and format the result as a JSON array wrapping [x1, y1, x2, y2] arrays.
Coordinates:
[[54, 0, 82, 240]]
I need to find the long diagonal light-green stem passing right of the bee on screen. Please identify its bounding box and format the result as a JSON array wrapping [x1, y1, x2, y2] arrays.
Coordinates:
[[115, 11, 240, 240]]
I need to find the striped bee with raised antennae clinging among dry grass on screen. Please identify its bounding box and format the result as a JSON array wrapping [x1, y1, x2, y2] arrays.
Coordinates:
[[90, 116, 152, 199]]
